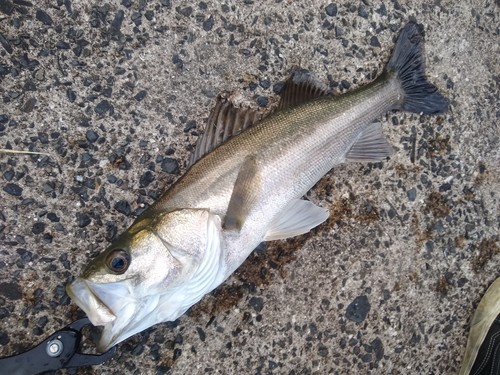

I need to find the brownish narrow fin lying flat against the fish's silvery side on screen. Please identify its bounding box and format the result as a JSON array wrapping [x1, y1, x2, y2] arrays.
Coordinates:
[[224, 155, 261, 231]]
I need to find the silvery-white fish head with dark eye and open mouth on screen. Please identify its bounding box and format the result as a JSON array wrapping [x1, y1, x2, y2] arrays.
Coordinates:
[[66, 209, 224, 352]]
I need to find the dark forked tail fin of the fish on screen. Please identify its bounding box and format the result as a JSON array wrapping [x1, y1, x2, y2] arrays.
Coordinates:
[[386, 22, 448, 114]]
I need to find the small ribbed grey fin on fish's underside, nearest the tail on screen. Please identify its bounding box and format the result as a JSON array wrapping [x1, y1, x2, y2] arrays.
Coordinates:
[[346, 122, 393, 162]]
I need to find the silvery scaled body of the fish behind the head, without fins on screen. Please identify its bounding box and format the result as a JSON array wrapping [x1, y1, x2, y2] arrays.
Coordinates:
[[150, 75, 402, 272]]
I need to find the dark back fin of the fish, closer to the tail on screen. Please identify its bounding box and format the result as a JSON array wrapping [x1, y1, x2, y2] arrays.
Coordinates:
[[276, 69, 332, 110]]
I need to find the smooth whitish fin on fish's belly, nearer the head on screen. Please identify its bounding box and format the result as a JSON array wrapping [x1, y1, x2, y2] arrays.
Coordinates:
[[264, 199, 328, 241]]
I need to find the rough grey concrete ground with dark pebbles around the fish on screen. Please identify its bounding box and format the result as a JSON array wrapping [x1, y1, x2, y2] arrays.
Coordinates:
[[0, 0, 500, 374]]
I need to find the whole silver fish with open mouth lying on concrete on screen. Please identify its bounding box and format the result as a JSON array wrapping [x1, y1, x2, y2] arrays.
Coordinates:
[[66, 22, 448, 352]]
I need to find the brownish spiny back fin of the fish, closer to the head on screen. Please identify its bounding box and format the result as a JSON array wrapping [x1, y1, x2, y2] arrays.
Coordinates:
[[189, 94, 265, 166]]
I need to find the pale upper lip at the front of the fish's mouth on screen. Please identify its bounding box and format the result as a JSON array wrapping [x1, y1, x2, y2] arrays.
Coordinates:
[[66, 277, 116, 326]]
